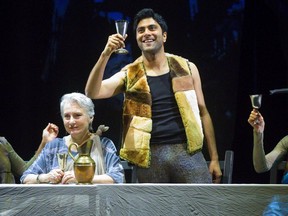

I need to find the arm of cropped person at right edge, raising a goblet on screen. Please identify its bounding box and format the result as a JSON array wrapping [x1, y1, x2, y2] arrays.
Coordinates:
[[248, 110, 288, 184]]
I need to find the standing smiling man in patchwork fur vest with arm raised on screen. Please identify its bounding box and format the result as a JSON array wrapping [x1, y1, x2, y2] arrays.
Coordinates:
[[85, 9, 222, 183]]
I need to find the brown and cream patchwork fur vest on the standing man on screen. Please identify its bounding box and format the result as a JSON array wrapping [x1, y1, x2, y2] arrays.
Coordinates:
[[120, 53, 203, 168]]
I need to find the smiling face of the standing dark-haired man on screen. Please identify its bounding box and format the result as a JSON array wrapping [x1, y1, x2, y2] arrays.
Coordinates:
[[136, 18, 167, 53]]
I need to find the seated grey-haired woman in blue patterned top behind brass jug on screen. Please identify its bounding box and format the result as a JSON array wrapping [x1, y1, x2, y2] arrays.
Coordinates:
[[20, 93, 124, 184]]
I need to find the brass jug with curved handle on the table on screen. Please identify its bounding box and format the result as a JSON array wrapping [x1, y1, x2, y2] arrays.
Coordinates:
[[68, 140, 95, 184]]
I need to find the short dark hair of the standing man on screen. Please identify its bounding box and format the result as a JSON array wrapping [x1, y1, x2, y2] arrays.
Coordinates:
[[133, 8, 168, 33]]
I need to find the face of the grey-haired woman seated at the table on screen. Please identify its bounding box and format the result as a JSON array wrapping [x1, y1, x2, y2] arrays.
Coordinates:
[[63, 103, 93, 140]]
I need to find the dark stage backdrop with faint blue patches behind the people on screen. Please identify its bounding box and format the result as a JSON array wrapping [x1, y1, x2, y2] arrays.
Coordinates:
[[0, 0, 288, 183]]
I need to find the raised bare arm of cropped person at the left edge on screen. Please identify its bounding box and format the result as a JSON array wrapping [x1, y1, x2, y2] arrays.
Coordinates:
[[0, 123, 58, 184]]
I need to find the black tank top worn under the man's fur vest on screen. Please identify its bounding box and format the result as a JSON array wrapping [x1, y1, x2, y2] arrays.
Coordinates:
[[147, 73, 187, 144]]
